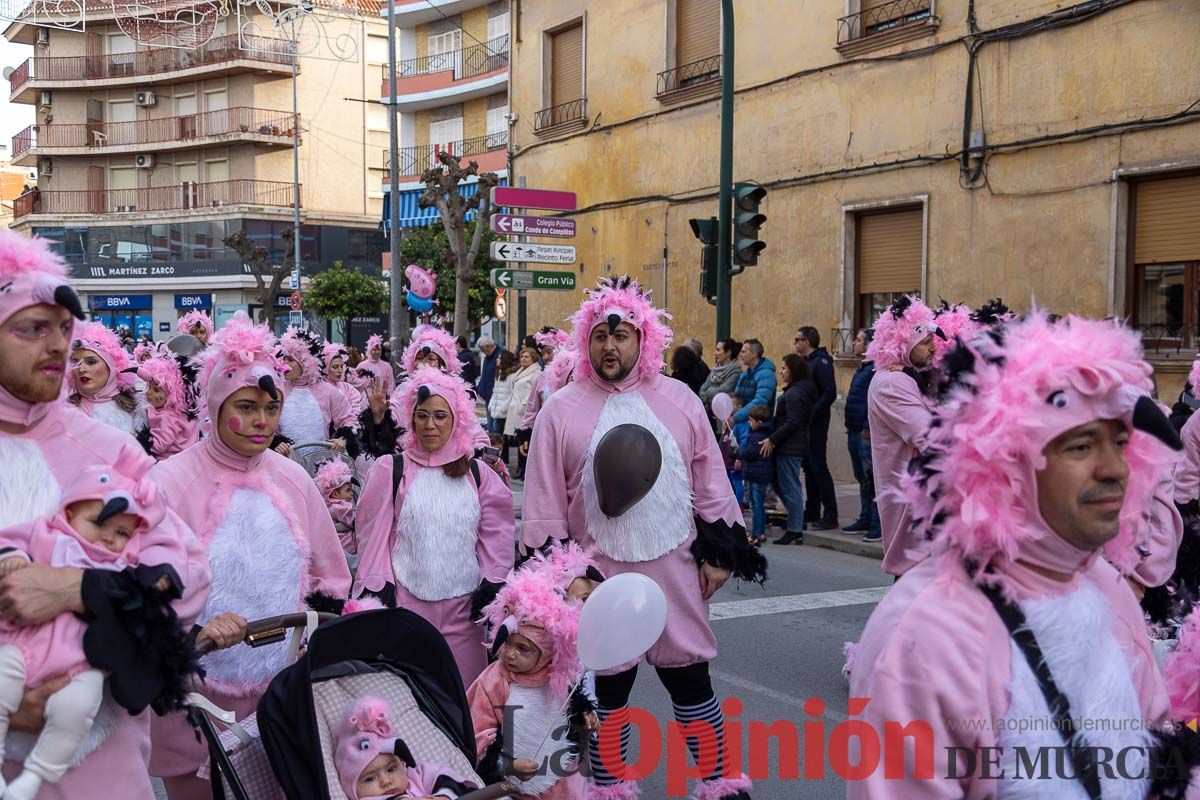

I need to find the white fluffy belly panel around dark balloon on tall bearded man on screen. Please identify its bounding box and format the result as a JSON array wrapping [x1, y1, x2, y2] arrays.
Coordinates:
[[582, 391, 692, 561]]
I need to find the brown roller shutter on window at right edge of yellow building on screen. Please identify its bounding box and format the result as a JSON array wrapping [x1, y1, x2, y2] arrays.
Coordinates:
[[1134, 175, 1200, 264]]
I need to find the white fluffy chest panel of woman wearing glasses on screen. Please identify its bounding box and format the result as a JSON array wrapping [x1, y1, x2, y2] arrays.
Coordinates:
[[391, 468, 479, 601]]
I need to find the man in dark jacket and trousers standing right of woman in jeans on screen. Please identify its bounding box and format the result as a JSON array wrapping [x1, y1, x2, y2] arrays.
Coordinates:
[[796, 325, 839, 530]]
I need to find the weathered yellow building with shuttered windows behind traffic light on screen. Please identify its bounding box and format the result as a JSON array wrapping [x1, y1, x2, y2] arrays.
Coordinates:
[[510, 0, 1200, 398]]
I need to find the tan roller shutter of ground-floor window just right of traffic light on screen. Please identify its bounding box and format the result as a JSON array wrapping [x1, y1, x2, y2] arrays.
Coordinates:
[[858, 209, 923, 294]]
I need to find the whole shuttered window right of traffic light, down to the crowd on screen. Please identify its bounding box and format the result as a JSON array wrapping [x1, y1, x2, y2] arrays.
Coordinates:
[[854, 206, 924, 327]]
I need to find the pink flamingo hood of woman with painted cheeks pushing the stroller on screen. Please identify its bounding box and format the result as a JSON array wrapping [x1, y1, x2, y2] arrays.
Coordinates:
[[196, 311, 287, 425]]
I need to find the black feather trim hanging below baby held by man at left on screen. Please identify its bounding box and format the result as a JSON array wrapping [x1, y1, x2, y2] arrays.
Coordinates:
[[80, 566, 204, 715]]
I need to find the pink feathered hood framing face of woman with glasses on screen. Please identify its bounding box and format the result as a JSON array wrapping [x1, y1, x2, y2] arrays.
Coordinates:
[[391, 366, 479, 467]]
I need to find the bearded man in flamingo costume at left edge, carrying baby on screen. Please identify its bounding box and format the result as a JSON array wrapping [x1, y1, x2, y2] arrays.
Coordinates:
[[0, 231, 210, 800]]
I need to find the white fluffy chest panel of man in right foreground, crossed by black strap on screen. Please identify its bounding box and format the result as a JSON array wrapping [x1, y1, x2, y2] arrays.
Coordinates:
[[997, 579, 1151, 800]]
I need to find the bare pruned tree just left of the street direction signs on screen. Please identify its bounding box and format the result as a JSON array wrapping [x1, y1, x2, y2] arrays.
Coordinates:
[[420, 152, 500, 336]]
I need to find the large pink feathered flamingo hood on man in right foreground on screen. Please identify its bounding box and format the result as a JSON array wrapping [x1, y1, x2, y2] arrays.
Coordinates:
[[902, 311, 1182, 585]]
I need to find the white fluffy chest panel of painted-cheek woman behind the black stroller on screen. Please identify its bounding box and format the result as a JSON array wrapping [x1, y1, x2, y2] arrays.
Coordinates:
[[200, 488, 308, 692]]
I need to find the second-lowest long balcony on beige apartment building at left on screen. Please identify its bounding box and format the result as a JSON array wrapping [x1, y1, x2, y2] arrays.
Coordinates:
[[12, 107, 294, 166]]
